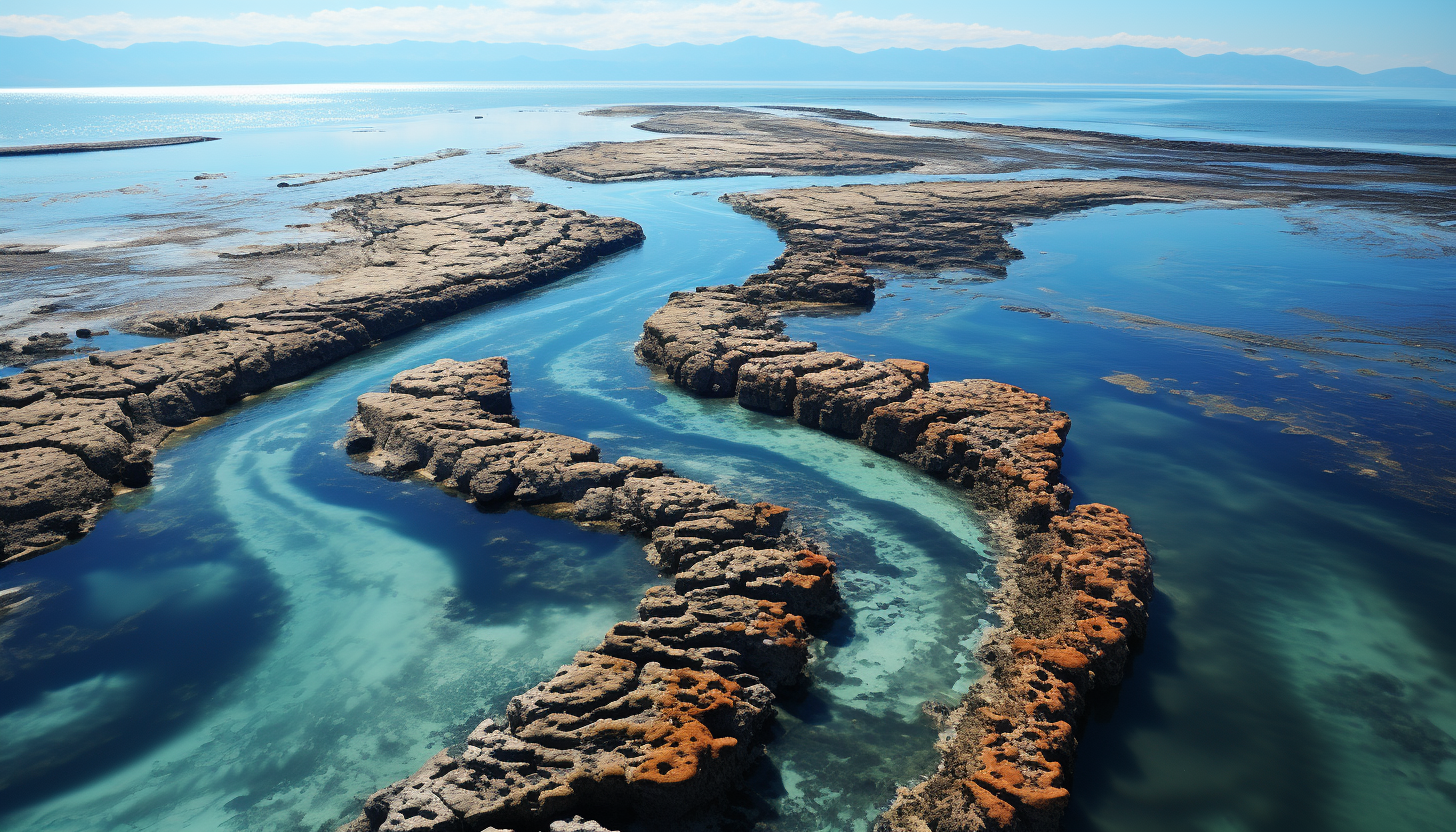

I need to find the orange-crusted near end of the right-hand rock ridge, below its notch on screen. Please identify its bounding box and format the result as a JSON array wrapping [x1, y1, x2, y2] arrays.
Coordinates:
[[877, 503, 1153, 832]]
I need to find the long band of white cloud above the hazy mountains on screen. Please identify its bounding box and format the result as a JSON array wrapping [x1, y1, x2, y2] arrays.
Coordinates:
[[0, 0, 1397, 71]]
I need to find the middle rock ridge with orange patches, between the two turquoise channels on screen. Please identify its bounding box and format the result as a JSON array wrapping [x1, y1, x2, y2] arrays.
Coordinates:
[[341, 358, 839, 832]]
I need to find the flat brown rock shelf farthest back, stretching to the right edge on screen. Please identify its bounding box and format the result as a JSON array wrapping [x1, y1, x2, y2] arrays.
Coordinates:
[[513, 106, 1456, 221]]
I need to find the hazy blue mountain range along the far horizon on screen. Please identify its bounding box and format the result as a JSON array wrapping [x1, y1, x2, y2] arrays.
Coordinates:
[[0, 36, 1456, 87]]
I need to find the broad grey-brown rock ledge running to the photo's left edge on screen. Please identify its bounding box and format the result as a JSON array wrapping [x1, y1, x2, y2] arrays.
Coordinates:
[[0, 185, 642, 561]]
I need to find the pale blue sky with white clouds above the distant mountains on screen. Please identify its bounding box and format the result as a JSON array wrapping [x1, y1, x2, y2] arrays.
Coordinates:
[[0, 0, 1456, 73]]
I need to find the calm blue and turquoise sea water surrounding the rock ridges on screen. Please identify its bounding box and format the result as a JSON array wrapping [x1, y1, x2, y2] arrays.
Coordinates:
[[0, 86, 1456, 832]]
